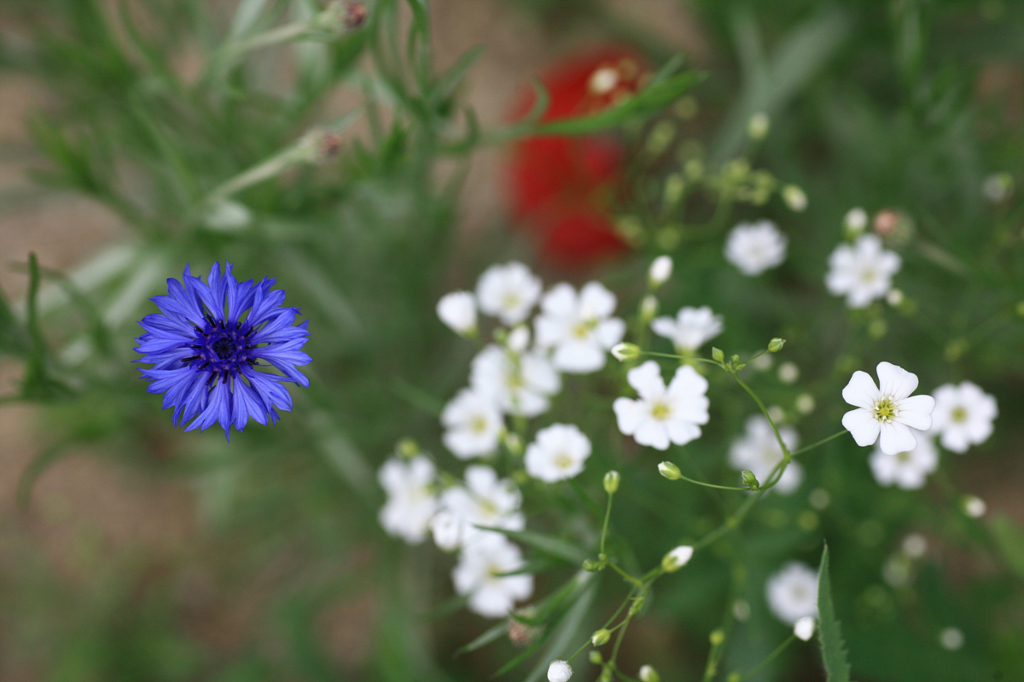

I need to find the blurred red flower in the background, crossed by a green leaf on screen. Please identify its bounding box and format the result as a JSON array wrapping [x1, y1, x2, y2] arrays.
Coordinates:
[[510, 47, 645, 265]]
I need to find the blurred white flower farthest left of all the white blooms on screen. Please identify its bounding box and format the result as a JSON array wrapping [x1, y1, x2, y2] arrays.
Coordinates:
[[377, 456, 437, 545]]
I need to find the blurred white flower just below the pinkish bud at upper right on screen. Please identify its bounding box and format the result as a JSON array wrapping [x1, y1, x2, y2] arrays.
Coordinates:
[[825, 235, 902, 308]]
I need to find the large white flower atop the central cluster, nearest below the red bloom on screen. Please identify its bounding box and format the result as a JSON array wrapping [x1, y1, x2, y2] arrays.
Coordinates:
[[534, 282, 626, 374]]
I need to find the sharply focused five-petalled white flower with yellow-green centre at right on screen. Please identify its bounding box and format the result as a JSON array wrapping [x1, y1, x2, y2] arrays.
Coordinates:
[[843, 363, 935, 455]]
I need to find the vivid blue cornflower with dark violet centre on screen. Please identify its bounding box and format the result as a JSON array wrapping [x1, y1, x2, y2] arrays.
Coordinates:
[[135, 258, 310, 440]]
